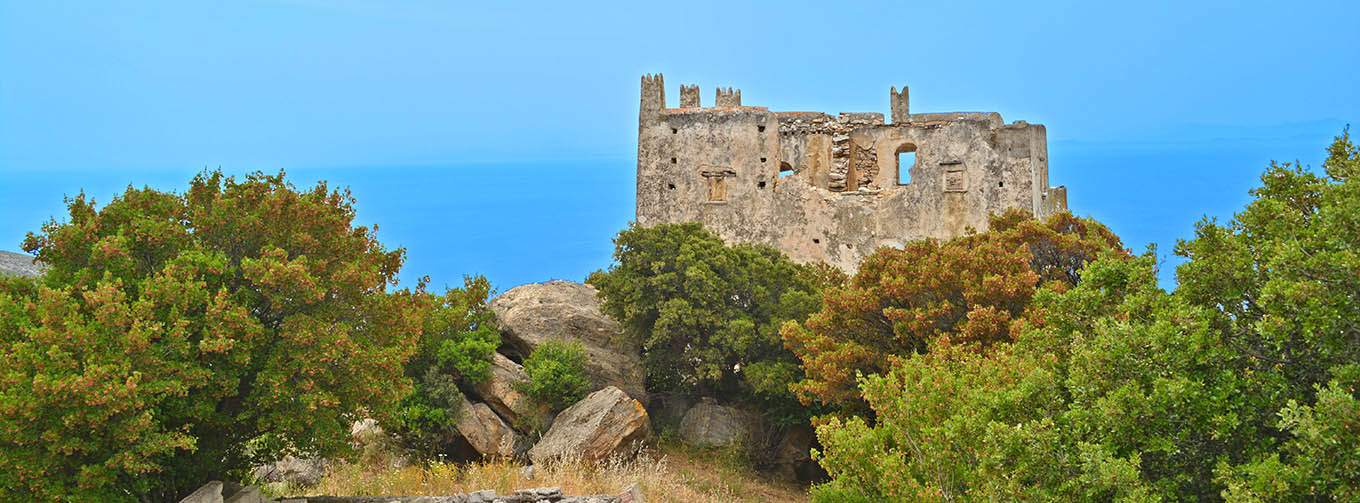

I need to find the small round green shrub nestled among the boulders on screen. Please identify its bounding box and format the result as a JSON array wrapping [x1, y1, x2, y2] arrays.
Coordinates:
[[515, 340, 590, 412]]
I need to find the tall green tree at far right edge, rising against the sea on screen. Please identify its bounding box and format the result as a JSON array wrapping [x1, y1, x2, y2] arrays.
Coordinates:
[[1176, 128, 1360, 502]]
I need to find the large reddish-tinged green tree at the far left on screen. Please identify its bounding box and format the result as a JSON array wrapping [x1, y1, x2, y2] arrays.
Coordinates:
[[0, 171, 424, 502]]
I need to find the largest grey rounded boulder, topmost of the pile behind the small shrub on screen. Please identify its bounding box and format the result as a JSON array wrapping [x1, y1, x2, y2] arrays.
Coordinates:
[[491, 280, 646, 401]]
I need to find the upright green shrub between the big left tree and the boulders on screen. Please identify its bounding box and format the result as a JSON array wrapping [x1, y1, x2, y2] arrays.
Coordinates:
[[393, 276, 500, 458]]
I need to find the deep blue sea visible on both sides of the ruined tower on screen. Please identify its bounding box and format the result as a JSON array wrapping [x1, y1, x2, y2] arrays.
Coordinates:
[[0, 121, 1344, 291]]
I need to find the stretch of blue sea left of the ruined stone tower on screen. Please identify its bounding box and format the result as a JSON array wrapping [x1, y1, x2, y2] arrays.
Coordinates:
[[0, 159, 636, 291]]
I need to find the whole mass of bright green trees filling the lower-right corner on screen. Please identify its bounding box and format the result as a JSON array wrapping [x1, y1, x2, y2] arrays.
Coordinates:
[[813, 130, 1360, 502]]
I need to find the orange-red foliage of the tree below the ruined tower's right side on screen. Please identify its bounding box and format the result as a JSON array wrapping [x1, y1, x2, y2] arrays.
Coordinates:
[[781, 209, 1127, 412]]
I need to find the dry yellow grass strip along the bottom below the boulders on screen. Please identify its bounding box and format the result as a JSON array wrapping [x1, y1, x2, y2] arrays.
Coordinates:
[[265, 446, 808, 503]]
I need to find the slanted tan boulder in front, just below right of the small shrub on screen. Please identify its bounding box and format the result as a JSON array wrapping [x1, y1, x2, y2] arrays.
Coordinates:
[[529, 386, 651, 464]]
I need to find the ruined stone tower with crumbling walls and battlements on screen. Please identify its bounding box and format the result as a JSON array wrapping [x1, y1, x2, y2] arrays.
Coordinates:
[[638, 75, 1068, 271]]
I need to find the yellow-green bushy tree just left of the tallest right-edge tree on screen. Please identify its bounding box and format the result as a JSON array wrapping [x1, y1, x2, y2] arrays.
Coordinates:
[[813, 254, 1270, 502]]
